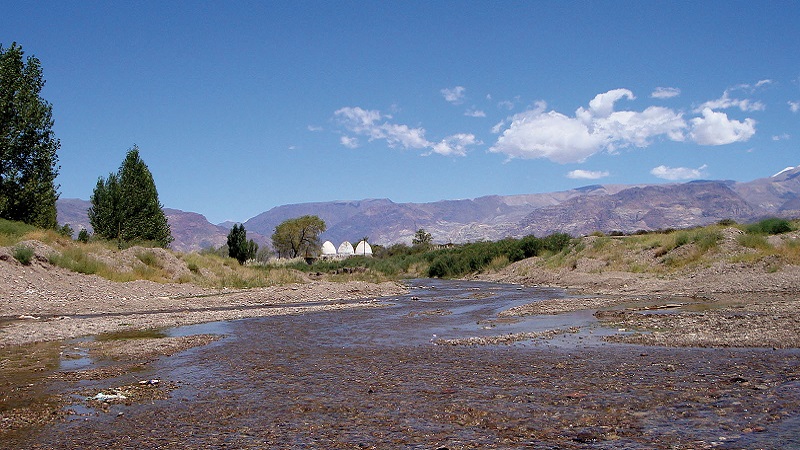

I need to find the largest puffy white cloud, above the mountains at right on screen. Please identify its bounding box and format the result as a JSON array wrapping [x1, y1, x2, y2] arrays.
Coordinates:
[[489, 89, 687, 163]]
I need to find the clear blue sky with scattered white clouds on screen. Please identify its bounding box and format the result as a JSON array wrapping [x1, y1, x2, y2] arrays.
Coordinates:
[[0, 1, 800, 223]]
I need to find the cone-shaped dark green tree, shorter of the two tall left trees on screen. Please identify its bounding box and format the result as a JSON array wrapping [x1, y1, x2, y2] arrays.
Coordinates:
[[89, 145, 173, 248]]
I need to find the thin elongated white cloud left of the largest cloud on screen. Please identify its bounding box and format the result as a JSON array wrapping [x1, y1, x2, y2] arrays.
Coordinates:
[[334, 106, 479, 156]]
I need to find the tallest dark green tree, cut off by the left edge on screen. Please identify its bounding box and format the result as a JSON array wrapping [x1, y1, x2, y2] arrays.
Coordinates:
[[0, 42, 61, 228]]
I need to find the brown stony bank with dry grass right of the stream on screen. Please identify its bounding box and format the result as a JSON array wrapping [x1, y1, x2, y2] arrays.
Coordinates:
[[477, 228, 800, 348]]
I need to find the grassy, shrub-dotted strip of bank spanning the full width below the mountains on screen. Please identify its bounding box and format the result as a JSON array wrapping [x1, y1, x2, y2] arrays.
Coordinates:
[[0, 219, 800, 288]]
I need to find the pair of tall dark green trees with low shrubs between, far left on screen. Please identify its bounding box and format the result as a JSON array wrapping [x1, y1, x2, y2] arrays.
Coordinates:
[[0, 42, 173, 247]]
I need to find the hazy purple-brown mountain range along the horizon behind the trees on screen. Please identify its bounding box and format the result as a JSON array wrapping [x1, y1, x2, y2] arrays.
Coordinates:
[[57, 166, 800, 252]]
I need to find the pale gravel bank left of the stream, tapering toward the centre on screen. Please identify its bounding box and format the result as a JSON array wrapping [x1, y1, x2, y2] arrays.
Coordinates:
[[0, 261, 405, 347]]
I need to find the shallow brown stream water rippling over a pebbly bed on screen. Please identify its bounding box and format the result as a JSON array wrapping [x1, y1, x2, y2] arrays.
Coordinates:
[[10, 280, 800, 449]]
